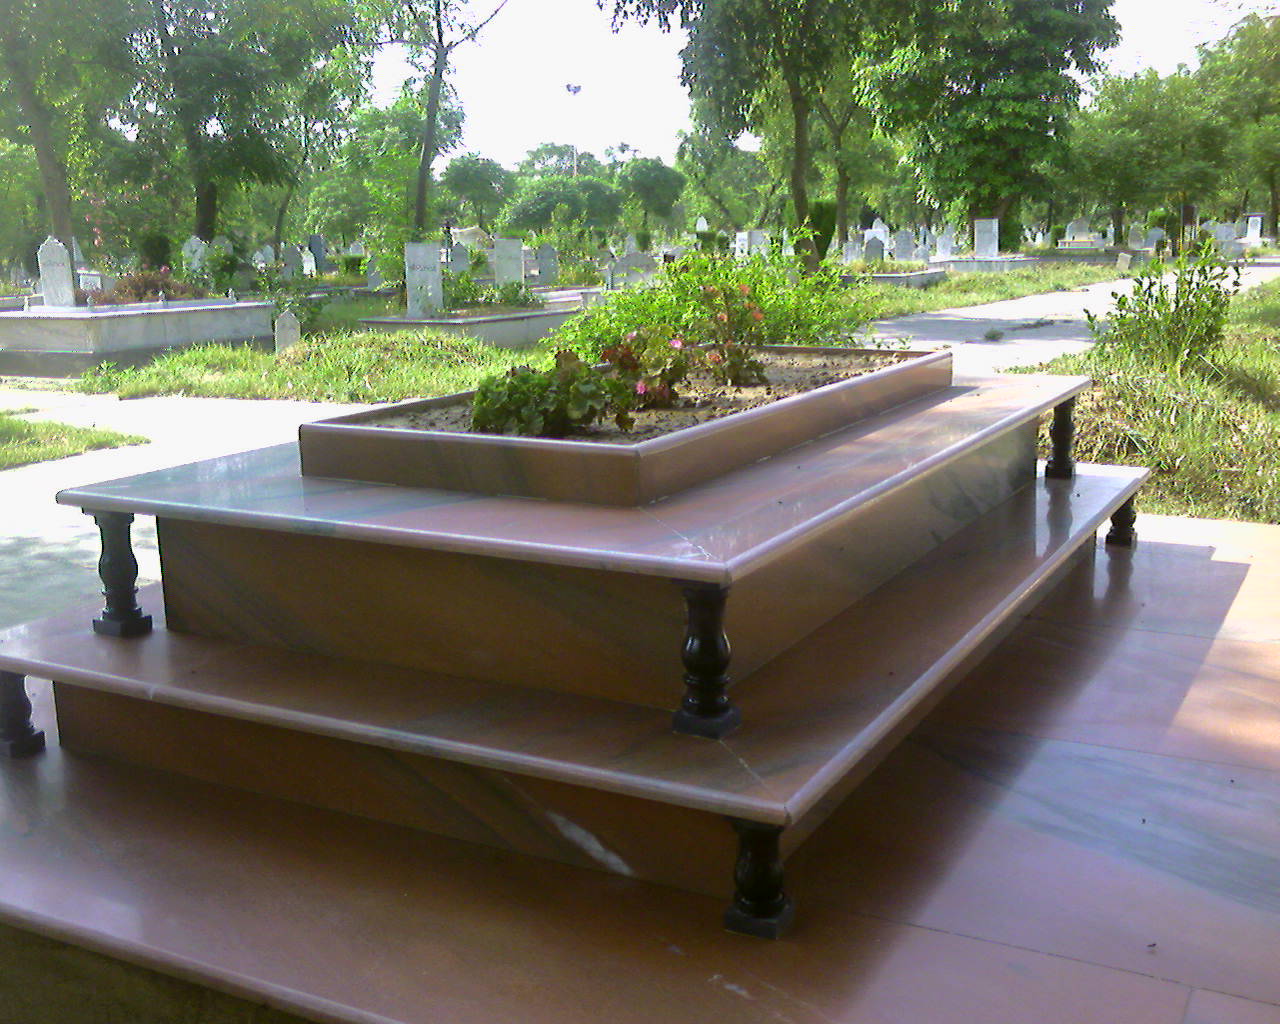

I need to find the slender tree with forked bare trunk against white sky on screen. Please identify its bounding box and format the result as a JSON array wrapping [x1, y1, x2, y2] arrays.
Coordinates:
[[358, 0, 507, 238]]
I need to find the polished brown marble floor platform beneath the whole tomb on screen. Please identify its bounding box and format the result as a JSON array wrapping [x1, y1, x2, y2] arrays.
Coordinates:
[[0, 516, 1280, 1024]]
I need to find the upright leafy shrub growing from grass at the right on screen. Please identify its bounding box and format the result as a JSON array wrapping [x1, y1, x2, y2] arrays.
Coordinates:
[[1088, 246, 1240, 372]]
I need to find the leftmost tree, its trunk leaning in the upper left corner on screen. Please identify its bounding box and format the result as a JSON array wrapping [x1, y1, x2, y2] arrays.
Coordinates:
[[0, 0, 132, 251]]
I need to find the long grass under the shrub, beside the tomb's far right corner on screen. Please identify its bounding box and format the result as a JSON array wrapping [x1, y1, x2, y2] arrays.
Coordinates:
[[1028, 282, 1280, 524]]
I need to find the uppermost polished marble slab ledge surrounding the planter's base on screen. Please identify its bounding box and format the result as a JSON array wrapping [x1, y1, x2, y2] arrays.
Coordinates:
[[58, 375, 1087, 582]]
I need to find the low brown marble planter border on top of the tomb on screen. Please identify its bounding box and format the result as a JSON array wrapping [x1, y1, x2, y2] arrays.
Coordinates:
[[298, 348, 951, 506]]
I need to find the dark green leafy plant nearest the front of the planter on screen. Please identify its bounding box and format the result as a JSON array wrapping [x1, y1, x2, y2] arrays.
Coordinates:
[[471, 351, 635, 438]]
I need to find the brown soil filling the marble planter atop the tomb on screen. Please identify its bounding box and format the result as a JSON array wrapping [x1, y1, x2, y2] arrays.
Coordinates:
[[384, 352, 908, 444]]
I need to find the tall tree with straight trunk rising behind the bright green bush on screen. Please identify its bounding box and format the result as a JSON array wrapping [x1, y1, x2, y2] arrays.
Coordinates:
[[600, 0, 936, 268]]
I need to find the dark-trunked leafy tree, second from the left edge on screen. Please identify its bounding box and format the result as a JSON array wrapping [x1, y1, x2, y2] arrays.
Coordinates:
[[125, 0, 352, 239]]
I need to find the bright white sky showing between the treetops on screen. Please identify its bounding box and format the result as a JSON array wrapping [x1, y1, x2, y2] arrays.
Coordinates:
[[374, 0, 1280, 166]]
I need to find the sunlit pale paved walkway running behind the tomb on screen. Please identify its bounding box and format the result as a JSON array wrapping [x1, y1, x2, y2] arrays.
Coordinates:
[[0, 266, 1280, 627]]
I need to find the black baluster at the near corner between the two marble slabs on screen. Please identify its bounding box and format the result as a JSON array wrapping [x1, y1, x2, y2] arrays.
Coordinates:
[[672, 584, 742, 740]]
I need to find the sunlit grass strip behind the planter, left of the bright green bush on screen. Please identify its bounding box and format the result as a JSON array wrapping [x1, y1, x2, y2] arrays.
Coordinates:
[[77, 330, 549, 402]]
